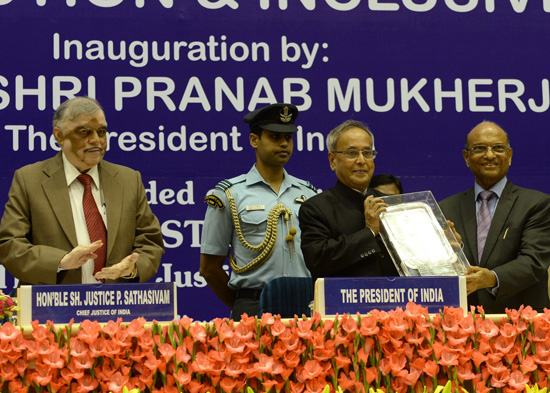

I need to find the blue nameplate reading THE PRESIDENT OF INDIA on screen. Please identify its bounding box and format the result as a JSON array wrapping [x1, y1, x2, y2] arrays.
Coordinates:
[[314, 276, 468, 316]]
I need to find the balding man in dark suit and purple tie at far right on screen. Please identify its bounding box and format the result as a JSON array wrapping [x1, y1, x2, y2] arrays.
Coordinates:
[[439, 121, 550, 314]]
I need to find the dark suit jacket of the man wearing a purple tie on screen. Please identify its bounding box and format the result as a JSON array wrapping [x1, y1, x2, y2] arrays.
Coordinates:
[[439, 181, 550, 314]]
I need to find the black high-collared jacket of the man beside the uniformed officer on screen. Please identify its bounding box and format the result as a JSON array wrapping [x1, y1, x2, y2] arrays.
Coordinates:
[[299, 181, 398, 282]]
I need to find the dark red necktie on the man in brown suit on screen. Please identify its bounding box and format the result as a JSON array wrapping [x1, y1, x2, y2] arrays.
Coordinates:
[[77, 175, 107, 281]]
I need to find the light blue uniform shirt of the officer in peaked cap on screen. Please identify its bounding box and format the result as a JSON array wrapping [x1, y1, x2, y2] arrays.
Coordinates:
[[201, 165, 316, 289]]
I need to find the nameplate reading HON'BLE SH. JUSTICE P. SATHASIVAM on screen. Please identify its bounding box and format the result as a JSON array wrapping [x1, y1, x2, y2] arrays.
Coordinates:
[[18, 283, 177, 326]]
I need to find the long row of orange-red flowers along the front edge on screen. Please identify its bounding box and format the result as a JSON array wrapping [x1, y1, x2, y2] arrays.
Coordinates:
[[0, 303, 550, 393]]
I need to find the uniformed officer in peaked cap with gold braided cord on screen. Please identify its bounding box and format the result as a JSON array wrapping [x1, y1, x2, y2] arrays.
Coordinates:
[[200, 104, 316, 321]]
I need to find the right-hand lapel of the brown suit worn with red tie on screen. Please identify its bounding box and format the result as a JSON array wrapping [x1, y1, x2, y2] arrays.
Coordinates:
[[99, 161, 124, 263]]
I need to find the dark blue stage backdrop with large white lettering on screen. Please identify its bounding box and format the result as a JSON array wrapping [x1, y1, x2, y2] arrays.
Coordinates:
[[0, 0, 550, 320]]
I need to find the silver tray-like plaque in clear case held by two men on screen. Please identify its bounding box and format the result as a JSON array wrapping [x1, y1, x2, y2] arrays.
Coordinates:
[[380, 191, 470, 276]]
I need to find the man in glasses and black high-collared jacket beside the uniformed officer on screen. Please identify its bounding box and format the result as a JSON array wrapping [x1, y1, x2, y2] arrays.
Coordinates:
[[299, 120, 398, 281]]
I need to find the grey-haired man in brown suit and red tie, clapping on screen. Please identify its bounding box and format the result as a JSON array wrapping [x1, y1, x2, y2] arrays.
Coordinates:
[[0, 97, 164, 284]]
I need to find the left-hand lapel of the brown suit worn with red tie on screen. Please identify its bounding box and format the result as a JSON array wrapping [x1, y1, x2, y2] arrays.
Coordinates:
[[42, 153, 78, 247]]
